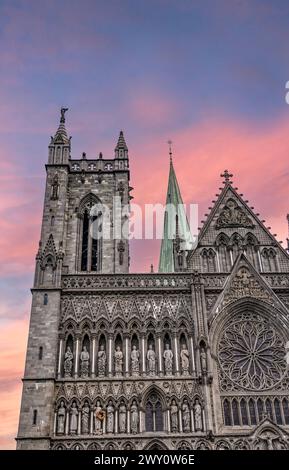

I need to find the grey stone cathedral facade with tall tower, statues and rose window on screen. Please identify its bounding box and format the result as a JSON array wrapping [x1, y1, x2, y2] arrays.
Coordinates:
[[17, 109, 289, 450]]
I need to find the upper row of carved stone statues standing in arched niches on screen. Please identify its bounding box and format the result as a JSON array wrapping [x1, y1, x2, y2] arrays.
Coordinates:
[[64, 343, 207, 378]]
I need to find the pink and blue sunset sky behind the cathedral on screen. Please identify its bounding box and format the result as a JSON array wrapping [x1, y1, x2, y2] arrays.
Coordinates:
[[0, 0, 289, 449]]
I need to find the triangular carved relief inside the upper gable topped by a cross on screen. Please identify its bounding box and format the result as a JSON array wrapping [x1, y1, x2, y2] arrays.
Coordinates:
[[216, 199, 254, 229]]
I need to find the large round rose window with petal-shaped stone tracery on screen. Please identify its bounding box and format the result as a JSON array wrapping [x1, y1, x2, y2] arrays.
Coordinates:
[[218, 313, 287, 390]]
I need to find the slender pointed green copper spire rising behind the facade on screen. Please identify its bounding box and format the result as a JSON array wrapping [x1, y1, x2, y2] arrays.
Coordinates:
[[159, 146, 193, 273]]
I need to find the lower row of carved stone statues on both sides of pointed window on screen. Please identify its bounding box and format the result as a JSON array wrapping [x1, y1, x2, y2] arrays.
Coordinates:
[[55, 399, 204, 436]]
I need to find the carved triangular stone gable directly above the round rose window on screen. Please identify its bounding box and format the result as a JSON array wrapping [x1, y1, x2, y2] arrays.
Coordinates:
[[209, 254, 288, 322]]
